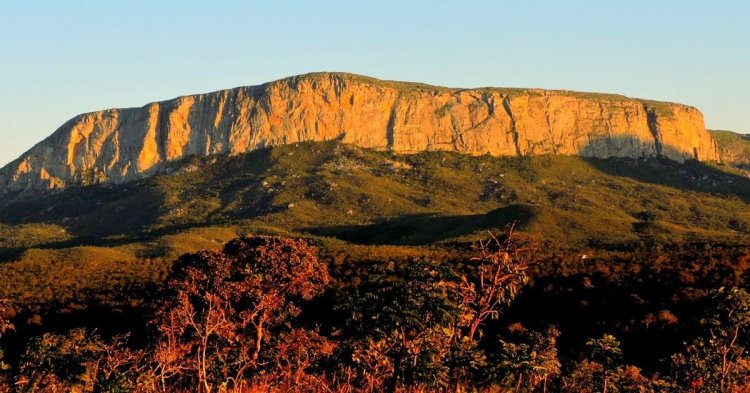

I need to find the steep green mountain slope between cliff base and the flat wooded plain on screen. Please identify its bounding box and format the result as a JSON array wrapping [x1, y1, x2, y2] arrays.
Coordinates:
[[0, 142, 750, 245]]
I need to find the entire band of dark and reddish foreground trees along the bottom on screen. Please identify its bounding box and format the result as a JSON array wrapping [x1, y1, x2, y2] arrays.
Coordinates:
[[0, 234, 750, 392]]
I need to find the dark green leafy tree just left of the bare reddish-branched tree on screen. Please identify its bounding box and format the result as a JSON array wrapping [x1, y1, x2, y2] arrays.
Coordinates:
[[339, 259, 457, 392]]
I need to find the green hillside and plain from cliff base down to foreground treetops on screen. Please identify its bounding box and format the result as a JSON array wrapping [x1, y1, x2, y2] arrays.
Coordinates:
[[0, 142, 750, 303]]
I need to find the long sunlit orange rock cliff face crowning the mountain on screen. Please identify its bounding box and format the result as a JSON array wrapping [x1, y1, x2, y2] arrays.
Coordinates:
[[0, 73, 718, 190]]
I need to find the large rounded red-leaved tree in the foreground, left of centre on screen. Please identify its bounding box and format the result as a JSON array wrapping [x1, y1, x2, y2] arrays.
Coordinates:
[[152, 237, 329, 392]]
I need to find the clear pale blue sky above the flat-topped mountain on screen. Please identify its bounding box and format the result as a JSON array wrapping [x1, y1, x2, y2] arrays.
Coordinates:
[[0, 0, 750, 164]]
